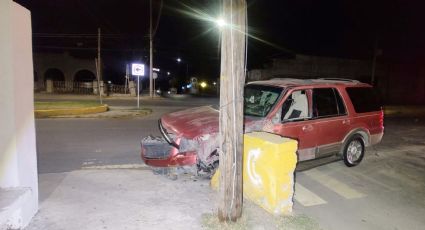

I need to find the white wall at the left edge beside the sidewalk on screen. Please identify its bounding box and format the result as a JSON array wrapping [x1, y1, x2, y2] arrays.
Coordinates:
[[0, 0, 38, 226]]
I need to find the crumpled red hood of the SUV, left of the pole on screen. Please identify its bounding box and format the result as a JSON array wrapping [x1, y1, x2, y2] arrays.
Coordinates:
[[161, 106, 219, 139]]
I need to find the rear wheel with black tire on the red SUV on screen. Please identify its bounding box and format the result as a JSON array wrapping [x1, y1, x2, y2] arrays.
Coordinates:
[[342, 134, 365, 167]]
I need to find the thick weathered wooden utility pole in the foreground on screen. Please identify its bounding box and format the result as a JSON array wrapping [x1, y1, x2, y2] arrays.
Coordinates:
[[218, 0, 247, 221]]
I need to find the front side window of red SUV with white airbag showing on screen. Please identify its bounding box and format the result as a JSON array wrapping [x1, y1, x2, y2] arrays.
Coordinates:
[[281, 90, 310, 121]]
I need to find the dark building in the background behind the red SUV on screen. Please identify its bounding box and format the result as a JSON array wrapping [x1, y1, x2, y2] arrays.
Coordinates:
[[247, 55, 425, 105]]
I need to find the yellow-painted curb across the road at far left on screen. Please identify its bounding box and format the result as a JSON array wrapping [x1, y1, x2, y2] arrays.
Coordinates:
[[34, 105, 108, 118]]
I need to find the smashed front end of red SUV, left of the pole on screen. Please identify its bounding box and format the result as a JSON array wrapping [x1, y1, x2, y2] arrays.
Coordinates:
[[141, 106, 219, 173]]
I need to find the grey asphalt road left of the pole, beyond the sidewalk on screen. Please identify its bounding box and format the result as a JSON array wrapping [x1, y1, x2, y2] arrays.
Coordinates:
[[36, 98, 218, 173]]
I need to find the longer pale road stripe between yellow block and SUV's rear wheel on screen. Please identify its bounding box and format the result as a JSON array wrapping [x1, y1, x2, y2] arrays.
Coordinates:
[[304, 169, 366, 199]]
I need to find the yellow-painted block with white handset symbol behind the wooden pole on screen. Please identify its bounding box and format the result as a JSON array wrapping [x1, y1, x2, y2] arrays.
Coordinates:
[[211, 132, 297, 215]]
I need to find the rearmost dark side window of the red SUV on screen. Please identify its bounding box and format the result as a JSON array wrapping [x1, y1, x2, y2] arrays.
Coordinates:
[[346, 87, 381, 113]]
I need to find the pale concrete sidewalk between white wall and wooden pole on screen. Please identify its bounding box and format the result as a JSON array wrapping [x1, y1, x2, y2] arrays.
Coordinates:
[[26, 167, 216, 230]]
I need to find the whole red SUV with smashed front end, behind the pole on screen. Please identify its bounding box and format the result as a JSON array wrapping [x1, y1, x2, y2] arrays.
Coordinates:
[[141, 78, 384, 172]]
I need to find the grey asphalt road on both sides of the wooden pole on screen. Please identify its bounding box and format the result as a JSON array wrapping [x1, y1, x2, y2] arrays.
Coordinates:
[[36, 99, 425, 229]]
